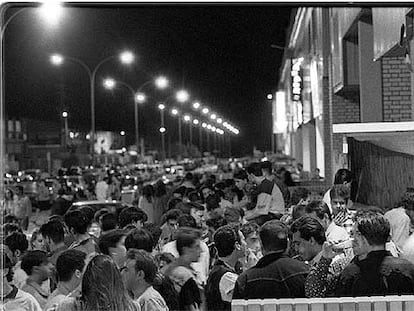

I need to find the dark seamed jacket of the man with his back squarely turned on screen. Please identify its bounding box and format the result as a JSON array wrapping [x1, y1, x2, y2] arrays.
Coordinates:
[[233, 253, 309, 299]]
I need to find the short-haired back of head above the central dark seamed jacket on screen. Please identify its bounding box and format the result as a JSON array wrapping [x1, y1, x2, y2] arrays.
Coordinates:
[[259, 220, 289, 252]]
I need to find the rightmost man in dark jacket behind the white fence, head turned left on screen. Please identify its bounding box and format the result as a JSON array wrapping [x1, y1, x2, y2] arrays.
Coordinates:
[[335, 212, 414, 296]]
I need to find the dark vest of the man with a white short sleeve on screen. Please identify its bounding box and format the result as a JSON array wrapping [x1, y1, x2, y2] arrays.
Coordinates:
[[206, 260, 236, 311]]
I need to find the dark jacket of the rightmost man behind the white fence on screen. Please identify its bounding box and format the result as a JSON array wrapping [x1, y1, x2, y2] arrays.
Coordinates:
[[335, 250, 414, 297]]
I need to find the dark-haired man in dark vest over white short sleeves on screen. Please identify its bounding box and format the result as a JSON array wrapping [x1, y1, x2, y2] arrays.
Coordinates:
[[206, 225, 246, 311]]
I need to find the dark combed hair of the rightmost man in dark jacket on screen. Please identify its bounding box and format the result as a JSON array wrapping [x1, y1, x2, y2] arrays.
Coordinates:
[[355, 211, 391, 246]]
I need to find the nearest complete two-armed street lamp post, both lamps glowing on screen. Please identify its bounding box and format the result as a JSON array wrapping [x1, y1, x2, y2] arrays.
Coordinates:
[[50, 51, 134, 163]]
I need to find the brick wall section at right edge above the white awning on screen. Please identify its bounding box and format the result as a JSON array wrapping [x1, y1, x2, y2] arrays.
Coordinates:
[[381, 57, 413, 122]]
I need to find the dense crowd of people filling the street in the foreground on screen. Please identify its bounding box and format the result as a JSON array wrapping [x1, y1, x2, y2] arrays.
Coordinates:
[[1, 162, 414, 311]]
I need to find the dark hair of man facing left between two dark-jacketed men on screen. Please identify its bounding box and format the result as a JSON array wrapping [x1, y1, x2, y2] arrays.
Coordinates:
[[291, 216, 326, 245]]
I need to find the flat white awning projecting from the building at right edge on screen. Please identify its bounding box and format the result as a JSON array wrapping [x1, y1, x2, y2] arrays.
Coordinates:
[[333, 121, 414, 155]]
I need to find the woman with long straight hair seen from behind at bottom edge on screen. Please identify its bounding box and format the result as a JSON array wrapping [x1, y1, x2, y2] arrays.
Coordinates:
[[56, 254, 140, 311]]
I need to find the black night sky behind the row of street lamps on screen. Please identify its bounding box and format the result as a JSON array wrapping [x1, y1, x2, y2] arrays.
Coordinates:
[[4, 4, 291, 155]]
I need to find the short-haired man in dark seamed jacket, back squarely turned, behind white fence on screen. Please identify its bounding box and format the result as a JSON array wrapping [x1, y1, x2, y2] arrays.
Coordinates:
[[233, 220, 308, 299]]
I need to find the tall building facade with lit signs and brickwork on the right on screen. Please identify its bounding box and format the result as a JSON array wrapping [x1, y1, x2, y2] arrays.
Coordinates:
[[276, 7, 414, 208]]
